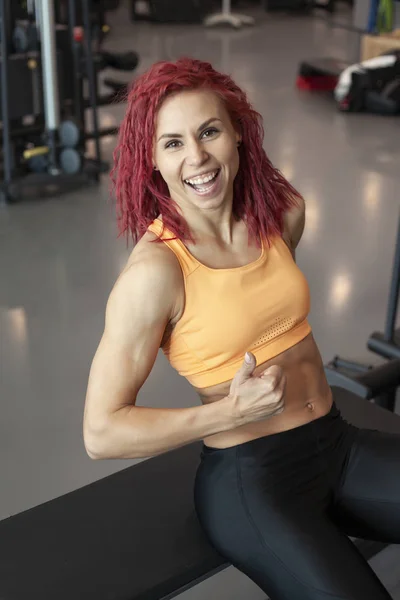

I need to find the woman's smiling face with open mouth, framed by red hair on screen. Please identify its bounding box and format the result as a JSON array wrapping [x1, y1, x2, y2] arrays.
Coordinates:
[[153, 90, 240, 216]]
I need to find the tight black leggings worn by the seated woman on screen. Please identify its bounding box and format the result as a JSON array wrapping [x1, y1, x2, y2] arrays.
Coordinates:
[[195, 396, 400, 600]]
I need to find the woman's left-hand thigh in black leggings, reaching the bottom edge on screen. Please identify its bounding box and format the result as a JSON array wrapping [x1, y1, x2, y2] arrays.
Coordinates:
[[195, 452, 390, 600]]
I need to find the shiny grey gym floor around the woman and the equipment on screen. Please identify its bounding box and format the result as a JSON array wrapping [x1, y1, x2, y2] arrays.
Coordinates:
[[0, 2, 400, 600]]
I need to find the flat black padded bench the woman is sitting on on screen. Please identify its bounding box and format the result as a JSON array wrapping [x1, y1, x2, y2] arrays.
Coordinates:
[[0, 388, 400, 600]]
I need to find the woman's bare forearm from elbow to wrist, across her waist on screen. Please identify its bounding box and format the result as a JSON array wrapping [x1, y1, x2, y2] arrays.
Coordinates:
[[87, 397, 237, 459]]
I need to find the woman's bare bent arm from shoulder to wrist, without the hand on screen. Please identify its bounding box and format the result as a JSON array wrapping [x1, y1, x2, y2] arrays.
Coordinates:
[[83, 248, 239, 459]]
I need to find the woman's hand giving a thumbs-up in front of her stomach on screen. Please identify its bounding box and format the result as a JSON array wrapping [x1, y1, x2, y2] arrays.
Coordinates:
[[228, 352, 286, 425]]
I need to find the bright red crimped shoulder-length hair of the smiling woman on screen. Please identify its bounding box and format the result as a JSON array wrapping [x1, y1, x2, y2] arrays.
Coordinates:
[[111, 58, 301, 243]]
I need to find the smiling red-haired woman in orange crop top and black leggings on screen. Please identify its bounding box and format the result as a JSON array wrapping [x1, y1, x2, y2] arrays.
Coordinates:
[[84, 59, 400, 600]]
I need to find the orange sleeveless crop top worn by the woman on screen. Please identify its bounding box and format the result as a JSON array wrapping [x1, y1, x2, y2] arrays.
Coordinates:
[[149, 219, 311, 388]]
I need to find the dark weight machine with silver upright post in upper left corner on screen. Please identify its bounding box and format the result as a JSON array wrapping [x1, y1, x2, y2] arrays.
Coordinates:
[[0, 0, 138, 203]]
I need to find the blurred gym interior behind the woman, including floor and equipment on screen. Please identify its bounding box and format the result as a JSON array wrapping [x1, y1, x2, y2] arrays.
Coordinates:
[[0, 0, 400, 600]]
